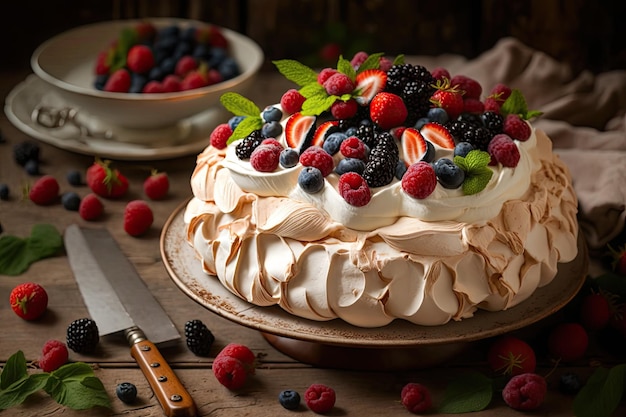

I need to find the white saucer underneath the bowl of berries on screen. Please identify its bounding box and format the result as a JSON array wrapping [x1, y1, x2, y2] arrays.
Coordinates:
[[4, 74, 228, 160]]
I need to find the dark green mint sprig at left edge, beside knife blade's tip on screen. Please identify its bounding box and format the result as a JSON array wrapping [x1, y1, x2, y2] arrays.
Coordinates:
[[0, 224, 63, 275]]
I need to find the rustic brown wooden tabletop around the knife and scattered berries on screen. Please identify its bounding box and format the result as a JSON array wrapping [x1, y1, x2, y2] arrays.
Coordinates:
[[0, 72, 626, 417]]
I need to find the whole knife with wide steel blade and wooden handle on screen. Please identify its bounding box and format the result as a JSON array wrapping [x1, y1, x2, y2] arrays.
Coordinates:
[[64, 224, 197, 417]]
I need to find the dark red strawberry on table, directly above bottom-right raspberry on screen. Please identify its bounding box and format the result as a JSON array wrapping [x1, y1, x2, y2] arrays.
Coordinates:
[[487, 335, 537, 376]]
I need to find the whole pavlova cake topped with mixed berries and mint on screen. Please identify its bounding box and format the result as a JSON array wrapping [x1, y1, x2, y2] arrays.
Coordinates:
[[184, 53, 578, 327]]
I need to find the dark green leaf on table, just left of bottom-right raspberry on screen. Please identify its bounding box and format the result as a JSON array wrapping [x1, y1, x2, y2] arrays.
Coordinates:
[[438, 372, 493, 414]]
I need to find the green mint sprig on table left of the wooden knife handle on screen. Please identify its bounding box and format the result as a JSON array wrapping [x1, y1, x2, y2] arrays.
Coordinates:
[[0, 350, 111, 410]]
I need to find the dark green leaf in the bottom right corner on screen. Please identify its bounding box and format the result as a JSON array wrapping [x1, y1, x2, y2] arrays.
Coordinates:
[[574, 364, 626, 417]]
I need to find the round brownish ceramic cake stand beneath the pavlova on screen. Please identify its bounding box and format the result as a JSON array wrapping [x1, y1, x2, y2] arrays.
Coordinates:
[[160, 203, 588, 370]]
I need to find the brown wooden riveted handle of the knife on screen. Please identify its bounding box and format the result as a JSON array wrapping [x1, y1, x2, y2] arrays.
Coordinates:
[[126, 329, 197, 417]]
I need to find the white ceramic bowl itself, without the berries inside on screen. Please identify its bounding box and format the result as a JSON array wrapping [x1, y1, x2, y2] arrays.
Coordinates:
[[31, 18, 264, 129]]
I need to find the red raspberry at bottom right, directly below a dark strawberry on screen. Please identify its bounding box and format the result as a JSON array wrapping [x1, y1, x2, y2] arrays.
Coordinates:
[[502, 373, 548, 411]]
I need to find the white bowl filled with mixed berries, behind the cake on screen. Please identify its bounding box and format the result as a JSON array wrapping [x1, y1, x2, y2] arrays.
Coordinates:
[[31, 18, 264, 130]]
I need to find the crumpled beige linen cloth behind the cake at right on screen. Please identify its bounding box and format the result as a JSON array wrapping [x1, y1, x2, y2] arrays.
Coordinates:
[[407, 38, 626, 248]]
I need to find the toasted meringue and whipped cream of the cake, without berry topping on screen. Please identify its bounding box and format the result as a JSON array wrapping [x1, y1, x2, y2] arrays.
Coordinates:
[[184, 130, 578, 327]]
